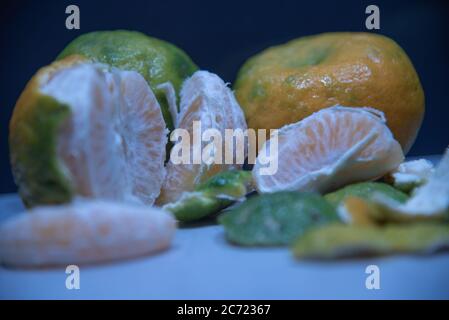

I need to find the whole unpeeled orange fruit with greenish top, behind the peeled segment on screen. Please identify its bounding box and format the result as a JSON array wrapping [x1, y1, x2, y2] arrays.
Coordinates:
[[234, 33, 424, 153]]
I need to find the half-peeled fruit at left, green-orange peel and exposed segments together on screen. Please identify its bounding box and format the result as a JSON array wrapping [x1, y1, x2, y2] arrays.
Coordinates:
[[9, 56, 167, 206]]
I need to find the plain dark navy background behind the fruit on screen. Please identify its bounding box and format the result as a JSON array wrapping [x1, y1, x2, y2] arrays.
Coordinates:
[[0, 0, 449, 192]]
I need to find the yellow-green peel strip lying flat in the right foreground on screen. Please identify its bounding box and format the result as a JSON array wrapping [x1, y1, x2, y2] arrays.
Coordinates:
[[293, 223, 449, 259]]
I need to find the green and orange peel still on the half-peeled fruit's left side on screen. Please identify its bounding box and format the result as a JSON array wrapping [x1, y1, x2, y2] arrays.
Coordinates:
[[9, 56, 84, 207]]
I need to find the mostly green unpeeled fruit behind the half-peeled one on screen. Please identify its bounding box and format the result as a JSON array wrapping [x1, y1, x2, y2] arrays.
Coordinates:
[[57, 30, 198, 130]]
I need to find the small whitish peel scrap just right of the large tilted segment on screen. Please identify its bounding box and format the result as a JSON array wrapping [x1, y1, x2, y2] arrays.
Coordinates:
[[387, 159, 435, 192]]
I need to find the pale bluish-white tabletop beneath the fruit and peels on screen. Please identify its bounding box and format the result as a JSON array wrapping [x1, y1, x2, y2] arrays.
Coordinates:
[[0, 155, 449, 299]]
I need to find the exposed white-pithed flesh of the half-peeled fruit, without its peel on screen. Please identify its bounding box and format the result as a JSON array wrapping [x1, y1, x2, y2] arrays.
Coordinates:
[[40, 63, 166, 204]]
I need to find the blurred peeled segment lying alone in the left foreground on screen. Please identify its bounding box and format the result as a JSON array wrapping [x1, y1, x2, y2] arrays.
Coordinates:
[[0, 200, 176, 267]]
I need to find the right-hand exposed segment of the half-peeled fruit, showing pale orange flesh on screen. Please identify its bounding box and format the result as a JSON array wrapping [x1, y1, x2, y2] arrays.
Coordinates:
[[111, 70, 168, 204]]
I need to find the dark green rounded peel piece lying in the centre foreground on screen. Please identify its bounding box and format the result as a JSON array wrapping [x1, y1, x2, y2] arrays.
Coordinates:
[[219, 192, 339, 246]]
